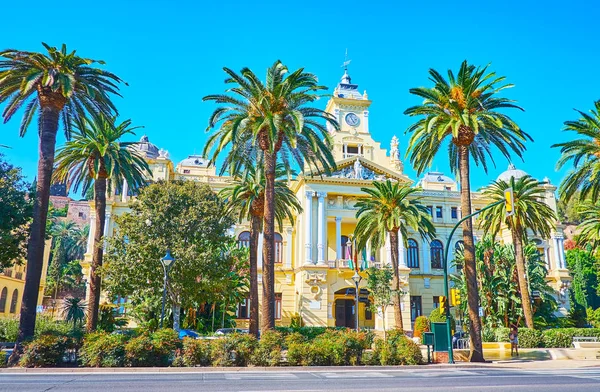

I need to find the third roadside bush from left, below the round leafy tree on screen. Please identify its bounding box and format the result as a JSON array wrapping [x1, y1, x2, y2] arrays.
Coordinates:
[[125, 329, 181, 366]]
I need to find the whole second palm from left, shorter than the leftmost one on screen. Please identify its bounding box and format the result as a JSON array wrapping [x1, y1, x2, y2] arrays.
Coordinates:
[[53, 116, 150, 331]]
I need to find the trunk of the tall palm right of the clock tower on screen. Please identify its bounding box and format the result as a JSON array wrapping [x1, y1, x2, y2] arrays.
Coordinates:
[[458, 146, 485, 362]]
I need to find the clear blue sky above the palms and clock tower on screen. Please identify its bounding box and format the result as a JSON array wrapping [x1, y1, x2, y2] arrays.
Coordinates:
[[0, 0, 600, 193]]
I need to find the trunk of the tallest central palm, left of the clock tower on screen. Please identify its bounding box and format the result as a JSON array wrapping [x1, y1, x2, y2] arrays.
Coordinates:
[[261, 151, 277, 332]]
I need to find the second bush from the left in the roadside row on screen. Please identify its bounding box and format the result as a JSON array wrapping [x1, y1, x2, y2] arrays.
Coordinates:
[[79, 332, 128, 367]]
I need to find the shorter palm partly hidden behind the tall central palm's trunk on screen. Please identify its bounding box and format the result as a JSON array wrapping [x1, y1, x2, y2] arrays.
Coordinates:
[[221, 164, 302, 336]]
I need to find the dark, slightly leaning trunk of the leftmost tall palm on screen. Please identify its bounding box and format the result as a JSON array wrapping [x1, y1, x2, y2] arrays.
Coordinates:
[[10, 105, 62, 364]]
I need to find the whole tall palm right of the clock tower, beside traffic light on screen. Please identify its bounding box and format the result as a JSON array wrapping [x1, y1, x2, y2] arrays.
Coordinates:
[[404, 61, 531, 362]]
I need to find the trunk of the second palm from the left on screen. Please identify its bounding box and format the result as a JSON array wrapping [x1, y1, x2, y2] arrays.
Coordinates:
[[87, 177, 106, 332]]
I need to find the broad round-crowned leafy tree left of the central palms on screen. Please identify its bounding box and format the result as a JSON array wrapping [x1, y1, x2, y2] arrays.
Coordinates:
[[103, 181, 240, 328]]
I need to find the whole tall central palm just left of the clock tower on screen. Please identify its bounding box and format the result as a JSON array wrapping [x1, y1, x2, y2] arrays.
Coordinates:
[[204, 61, 339, 330]]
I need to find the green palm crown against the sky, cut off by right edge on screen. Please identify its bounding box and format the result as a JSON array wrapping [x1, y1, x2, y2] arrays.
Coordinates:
[[552, 101, 600, 203]]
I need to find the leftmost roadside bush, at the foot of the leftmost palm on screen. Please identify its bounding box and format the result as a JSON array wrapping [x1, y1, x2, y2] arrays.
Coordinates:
[[19, 334, 70, 367]]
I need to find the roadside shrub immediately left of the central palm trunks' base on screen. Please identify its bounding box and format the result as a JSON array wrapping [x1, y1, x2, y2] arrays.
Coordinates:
[[211, 334, 258, 366]]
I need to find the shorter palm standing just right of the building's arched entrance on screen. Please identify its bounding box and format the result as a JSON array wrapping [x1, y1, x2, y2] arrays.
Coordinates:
[[354, 180, 435, 331]]
